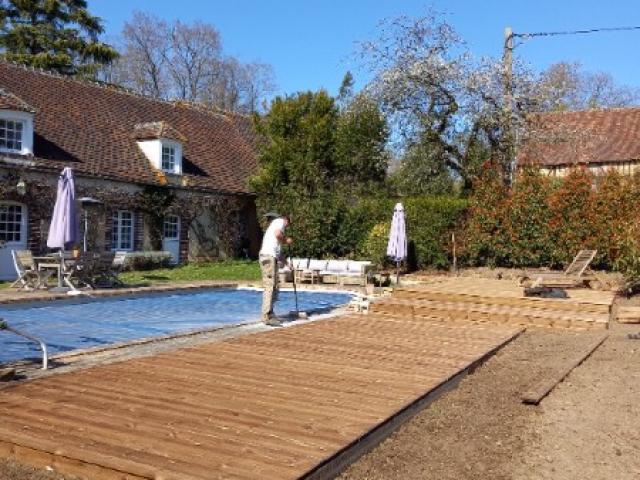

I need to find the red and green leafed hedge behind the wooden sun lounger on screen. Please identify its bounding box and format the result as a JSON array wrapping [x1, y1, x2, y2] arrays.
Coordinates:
[[463, 168, 640, 278]]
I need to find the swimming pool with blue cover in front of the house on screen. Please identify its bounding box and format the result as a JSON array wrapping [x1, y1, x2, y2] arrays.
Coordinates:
[[0, 289, 350, 364]]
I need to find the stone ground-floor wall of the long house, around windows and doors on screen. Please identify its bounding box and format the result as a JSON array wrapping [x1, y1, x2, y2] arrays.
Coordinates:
[[0, 169, 259, 262]]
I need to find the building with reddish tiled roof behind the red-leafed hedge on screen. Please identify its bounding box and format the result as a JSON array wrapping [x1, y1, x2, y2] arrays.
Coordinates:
[[518, 108, 640, 177]]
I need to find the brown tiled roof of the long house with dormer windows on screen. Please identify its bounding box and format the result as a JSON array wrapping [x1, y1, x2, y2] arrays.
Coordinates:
[[0, 62, 257, 193]]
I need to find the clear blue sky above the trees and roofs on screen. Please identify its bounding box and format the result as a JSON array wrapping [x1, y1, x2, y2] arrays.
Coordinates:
[[89, 0, 640, 97]]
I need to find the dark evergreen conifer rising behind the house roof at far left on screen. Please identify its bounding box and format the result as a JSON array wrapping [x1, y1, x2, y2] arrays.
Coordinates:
[[0, 0, 118, 75]]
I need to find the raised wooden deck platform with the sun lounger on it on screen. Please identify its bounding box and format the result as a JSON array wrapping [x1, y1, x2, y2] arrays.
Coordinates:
[[372, 277, 615, 330]]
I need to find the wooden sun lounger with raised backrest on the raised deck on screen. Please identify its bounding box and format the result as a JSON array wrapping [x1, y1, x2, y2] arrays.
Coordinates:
[[518, 250, 598, 295]]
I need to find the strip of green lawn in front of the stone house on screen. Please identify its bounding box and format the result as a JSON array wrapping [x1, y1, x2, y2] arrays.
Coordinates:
[[120, 260, 261, 285]]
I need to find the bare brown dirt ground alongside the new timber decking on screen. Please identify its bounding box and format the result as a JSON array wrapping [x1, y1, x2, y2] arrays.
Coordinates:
[[0, 312, 640, 480]]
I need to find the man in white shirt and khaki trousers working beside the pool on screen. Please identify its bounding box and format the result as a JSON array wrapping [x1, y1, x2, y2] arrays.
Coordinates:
[[259, 215, 292, 327]]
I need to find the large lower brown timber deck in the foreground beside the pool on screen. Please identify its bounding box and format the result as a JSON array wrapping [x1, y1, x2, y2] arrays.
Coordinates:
[[0, 315, 521, 480]]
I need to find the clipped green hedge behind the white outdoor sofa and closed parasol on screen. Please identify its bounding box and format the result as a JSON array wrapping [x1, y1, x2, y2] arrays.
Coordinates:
[[260, 192, 467, 268]]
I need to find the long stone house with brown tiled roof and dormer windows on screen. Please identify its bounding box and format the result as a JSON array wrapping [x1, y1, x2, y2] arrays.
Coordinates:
[[0, 62, 259, 279]]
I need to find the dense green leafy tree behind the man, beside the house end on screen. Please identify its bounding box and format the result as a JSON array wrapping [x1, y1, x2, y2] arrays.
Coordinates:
[[251, 91, 387, 256]]
